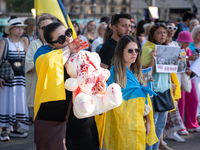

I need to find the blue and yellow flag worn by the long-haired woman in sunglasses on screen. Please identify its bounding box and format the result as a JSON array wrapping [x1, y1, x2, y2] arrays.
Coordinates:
[[104, 67, 158, 150]]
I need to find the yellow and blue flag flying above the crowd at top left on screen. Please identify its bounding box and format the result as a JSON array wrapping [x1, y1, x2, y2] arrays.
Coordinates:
[[34, 0, 76, 39]]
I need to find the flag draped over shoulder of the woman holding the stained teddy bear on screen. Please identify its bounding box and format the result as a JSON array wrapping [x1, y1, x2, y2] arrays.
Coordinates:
[[34, 45, 66, 119]]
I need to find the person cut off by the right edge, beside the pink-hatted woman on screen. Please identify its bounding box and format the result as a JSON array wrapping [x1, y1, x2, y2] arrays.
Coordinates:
[[189, 25, 200, 125]]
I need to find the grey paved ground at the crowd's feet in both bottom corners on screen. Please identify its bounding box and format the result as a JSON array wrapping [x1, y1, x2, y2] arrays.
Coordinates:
[[0, 125, 200, 150]]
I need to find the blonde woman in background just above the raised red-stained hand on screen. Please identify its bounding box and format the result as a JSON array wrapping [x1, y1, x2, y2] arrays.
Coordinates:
[[84, 20, 97, 51]]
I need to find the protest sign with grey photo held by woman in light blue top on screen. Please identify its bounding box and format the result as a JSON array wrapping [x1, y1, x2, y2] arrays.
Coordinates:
[[156, 45, 180, 73]]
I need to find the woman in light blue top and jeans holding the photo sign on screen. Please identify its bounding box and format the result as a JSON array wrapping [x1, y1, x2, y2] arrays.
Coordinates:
[[141, 23, 172, 150]]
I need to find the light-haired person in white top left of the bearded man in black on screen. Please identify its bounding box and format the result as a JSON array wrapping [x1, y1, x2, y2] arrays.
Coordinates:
[[91, 22, 107, 52]]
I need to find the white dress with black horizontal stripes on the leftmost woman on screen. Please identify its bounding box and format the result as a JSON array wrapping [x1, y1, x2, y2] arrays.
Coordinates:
[[0, 38, 29, 131]]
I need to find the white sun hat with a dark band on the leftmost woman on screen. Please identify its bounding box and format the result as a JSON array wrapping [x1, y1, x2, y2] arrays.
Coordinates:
[[5, 18, 27, 34]]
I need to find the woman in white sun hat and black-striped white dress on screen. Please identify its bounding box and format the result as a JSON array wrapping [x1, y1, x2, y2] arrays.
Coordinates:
[[0, 17, 29, 141]]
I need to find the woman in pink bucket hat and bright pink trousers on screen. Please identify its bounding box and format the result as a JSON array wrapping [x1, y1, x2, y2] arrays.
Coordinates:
[[176, 31, 200, 135]]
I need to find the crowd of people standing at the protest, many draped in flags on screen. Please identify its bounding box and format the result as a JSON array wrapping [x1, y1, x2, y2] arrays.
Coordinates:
[[0, 9, 200, 150]]
